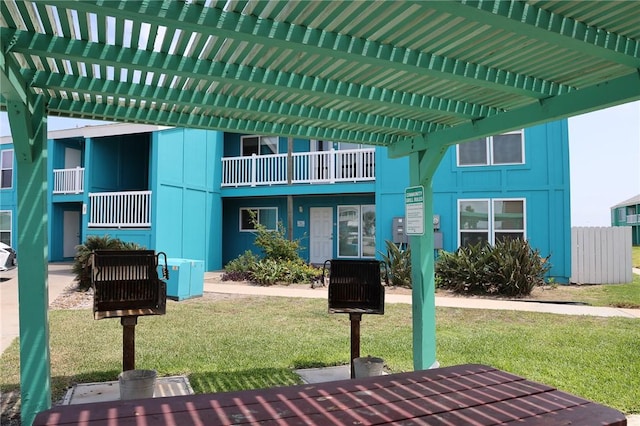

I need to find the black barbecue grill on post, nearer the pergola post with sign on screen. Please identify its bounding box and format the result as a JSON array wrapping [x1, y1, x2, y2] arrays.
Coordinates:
[[322, 259, 386, 378]]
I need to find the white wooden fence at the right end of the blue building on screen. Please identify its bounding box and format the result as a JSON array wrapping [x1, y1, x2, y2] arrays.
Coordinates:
[[571, 226, 633, 284]]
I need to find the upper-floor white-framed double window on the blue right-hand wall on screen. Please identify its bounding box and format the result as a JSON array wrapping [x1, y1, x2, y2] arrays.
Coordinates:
[[458, 131, 524, 166]]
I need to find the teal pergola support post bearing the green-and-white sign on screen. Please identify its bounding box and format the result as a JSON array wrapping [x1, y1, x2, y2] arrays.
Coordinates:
[[409, 147, 446, 370]]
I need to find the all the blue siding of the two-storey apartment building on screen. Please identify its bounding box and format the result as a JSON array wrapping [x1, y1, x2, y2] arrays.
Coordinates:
[[0, 120, 571, 282]]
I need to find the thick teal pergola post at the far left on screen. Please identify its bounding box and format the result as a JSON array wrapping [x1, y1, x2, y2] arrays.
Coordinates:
[[0, 49, 51, 425]]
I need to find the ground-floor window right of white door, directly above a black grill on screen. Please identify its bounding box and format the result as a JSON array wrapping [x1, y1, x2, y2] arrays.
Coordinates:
[[338, 205, 376, 258]]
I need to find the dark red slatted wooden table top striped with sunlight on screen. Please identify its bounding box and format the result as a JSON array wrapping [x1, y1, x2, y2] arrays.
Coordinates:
[[33, 364, 627, 426]]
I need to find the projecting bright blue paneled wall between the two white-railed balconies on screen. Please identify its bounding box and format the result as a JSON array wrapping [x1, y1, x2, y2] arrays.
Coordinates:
[[152, 129, 223, 271]]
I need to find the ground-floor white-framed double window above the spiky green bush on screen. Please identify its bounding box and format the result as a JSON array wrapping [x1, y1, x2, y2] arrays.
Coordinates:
[[458, 199, 526, 246]]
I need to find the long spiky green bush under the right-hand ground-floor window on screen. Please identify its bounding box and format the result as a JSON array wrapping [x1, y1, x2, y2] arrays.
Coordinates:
[[435, 239, 550, 297]]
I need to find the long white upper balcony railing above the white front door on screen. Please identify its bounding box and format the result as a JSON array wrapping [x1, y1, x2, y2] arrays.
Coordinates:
[[222, 148, 376, 187]]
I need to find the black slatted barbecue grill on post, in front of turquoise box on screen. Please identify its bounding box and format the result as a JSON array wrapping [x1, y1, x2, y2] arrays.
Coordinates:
[[90, 250, 169, 371]]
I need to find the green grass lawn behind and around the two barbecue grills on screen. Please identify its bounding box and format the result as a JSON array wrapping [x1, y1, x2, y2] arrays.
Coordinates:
[[0, 297, 640, 414]]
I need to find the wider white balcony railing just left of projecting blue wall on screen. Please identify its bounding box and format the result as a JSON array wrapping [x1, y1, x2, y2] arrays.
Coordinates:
[[89, 191, 151, 228]]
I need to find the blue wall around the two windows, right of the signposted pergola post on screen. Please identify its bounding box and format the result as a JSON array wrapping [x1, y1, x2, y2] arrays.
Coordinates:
[[433, 120, 571, 283]]
